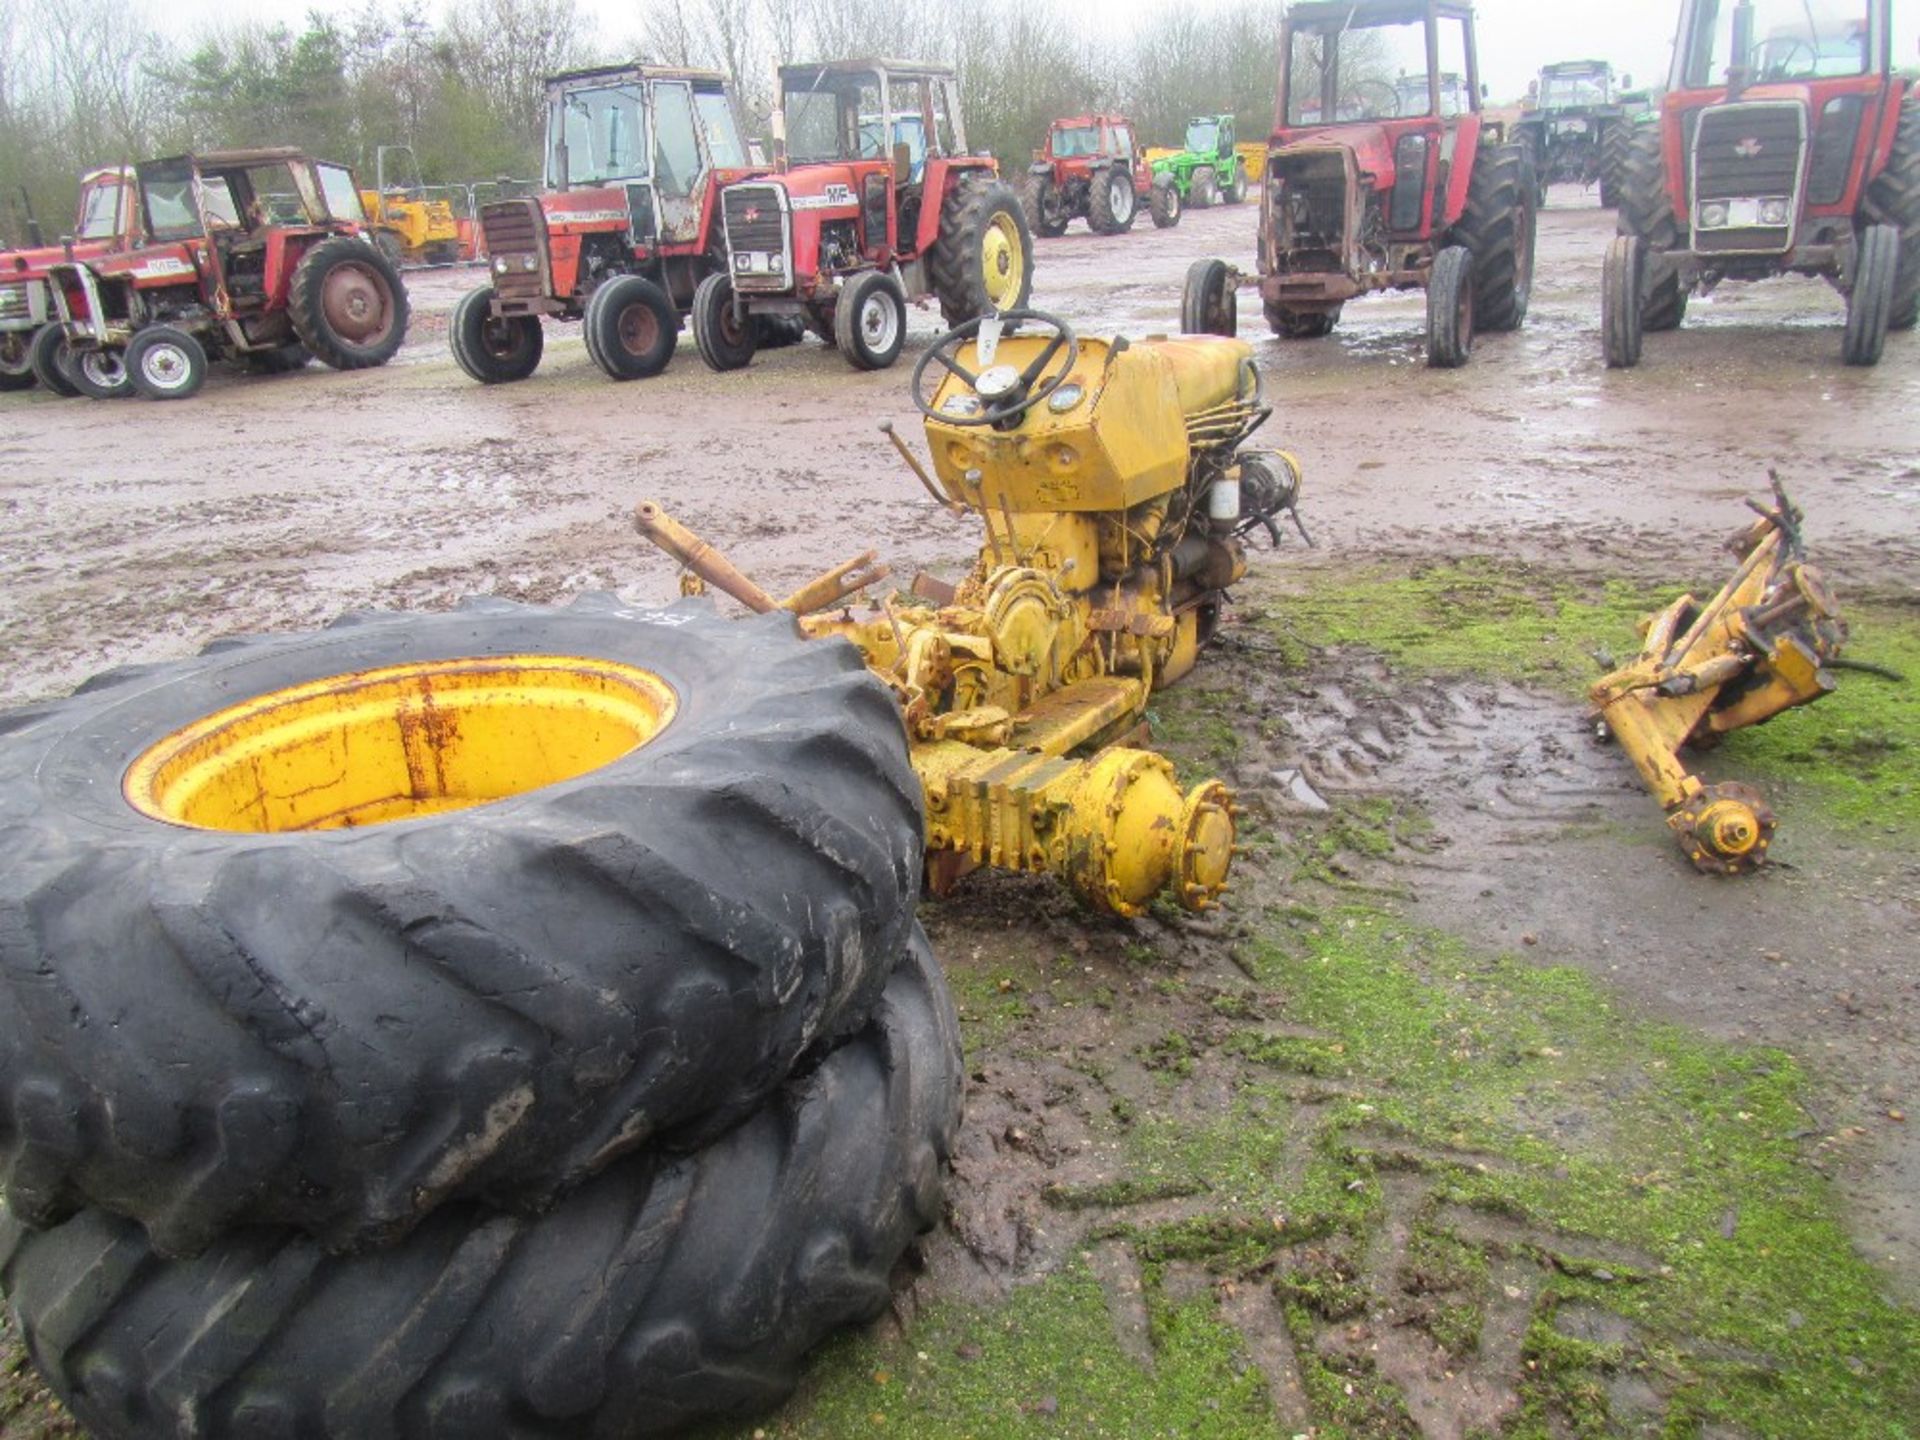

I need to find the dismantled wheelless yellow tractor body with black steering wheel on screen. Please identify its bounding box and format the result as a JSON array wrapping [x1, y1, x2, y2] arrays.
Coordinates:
[[637, 311, 1304, 916]]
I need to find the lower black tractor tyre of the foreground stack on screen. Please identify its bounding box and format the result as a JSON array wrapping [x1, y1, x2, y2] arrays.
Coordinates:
[[0, 935, 964, 1440]]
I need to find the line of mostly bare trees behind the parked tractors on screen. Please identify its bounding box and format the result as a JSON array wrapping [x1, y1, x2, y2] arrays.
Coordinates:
[[0, 0, 1281, 244]]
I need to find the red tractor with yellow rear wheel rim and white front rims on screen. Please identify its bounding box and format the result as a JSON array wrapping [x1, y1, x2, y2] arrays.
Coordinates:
[[693, 60, 1033, 371]]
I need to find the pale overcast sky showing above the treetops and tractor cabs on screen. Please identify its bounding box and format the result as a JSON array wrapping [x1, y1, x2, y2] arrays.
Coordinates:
[[146, 0, 1920, 100]]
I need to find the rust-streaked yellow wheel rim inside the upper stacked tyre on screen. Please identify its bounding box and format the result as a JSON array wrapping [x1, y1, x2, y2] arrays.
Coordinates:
[[123, 655, 678, 833]]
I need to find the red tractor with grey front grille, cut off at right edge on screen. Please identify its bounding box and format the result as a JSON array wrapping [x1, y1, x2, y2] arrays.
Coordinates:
[[1601, 0, 1920, 369]]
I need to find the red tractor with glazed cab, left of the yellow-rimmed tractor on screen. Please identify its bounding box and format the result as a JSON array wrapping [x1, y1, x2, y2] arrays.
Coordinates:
[[451, 65, 779, 384]]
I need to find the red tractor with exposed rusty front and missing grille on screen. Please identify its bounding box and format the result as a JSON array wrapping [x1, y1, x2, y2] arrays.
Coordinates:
[[1181, 0, 1538, 369]]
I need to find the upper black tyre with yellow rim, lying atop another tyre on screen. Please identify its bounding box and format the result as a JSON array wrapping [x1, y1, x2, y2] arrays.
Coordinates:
[[0, 595, 924, 1254]]
